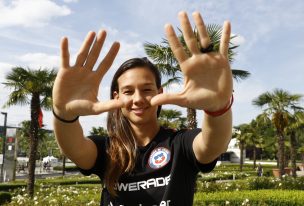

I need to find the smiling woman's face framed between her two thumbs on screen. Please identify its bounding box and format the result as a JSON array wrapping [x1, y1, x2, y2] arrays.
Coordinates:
[[114, 67, 162, 125]]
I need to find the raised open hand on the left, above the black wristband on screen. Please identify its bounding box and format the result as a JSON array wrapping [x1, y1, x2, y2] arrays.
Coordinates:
[[53, 31, 123, 120]]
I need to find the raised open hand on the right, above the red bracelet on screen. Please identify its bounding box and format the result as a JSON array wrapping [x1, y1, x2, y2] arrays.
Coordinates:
[[151, 12, 232, 111]]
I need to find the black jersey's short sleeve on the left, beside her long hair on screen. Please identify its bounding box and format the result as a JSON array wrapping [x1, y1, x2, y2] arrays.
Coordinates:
[[79, 136, 109, 180]]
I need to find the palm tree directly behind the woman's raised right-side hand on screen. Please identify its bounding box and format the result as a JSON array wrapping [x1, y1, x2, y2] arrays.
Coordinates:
[[144, 24, 250, 129]]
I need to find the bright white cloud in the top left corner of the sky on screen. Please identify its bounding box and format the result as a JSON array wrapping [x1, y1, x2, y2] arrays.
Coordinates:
[[0, 0, 71, 27]]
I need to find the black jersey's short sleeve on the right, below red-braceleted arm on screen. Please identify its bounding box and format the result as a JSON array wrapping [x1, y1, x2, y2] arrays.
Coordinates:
[[180, 129, 218, 173]]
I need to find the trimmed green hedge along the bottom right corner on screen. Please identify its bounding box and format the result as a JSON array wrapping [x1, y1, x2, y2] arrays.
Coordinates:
[[194, 190, 304, 206]]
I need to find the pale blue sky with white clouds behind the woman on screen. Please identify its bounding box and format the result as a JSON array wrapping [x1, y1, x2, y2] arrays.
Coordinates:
[[0, 0, 304, 135]]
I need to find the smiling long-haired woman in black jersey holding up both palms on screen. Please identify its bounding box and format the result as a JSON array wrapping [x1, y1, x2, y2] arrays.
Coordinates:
[[53, 12, 232, 206]]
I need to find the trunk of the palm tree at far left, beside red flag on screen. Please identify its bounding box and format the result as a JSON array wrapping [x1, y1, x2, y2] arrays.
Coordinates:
[[27, 94, 40, 198]]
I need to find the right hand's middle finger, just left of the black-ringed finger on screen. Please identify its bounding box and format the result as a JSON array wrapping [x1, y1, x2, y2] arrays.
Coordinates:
[[178, 12, 200, 54]]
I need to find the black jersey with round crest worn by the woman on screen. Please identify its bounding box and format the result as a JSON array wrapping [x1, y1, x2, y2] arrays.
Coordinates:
[[80, 128, 217, 206]]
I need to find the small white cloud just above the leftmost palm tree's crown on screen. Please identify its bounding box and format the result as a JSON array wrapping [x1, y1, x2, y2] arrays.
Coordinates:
[[17, 53, 60, 69]]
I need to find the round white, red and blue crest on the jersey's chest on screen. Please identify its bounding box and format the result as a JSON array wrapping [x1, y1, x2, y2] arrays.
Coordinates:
[[149, 147, 171, 169]]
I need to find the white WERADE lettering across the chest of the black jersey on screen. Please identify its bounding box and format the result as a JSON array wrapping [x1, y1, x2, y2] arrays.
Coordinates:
[[115, 175, 170, 191]]
